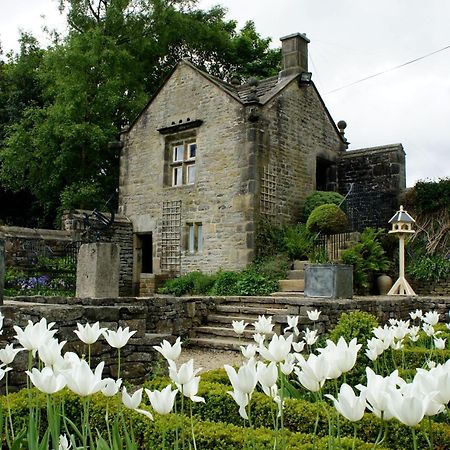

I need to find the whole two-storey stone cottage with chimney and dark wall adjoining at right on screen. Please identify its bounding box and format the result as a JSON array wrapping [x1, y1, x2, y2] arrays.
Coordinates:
[[119, 34, 405, 292]]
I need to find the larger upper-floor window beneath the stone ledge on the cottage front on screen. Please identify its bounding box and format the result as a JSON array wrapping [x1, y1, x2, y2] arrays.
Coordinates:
[[170, 142, 197, 186]]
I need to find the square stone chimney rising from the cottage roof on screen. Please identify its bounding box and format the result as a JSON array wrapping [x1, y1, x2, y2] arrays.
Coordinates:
[[280, 33, 310, 77]]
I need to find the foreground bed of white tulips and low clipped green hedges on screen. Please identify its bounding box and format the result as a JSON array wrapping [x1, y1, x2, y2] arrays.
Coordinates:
[[0, 311, 450, 450]]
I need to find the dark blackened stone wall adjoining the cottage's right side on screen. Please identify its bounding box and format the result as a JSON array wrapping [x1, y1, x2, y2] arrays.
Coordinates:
[[338, 144, 406, 231]]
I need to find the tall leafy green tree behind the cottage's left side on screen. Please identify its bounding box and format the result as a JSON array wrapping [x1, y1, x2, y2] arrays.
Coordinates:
[[0, 0, 280, 225]]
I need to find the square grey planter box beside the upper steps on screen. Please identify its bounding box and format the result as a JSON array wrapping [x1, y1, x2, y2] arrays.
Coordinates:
[[305, 264, 353, 298]]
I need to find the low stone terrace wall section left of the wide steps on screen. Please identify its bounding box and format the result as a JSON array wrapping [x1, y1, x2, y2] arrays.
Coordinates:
[[0, 297, 213, 389]]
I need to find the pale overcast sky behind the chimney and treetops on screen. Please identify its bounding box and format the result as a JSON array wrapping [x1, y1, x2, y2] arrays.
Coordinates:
[[0, 0, 450, 186]]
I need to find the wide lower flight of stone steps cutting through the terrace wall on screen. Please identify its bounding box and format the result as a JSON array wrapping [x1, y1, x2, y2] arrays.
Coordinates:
[[189, 297, 287, 350]]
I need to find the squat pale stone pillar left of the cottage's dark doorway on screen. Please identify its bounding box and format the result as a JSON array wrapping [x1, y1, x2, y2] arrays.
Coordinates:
[[76, 242, 119, 298]]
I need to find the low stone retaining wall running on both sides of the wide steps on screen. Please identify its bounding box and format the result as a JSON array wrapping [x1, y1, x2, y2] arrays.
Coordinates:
[[0, 296, 450, 389]]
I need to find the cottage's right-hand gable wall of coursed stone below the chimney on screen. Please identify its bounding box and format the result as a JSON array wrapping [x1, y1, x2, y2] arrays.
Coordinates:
[[258, 79, 343, 223]]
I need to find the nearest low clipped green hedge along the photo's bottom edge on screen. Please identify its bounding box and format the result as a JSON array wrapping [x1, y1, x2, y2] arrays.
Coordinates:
[[1, 386, 382, 450]]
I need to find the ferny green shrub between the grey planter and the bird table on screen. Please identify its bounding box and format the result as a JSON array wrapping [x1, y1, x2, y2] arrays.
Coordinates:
[[342, 228, 390, 292]]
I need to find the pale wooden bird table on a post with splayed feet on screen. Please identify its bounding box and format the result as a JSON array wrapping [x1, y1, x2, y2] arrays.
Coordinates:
[[387, 206, 416, 295]]
